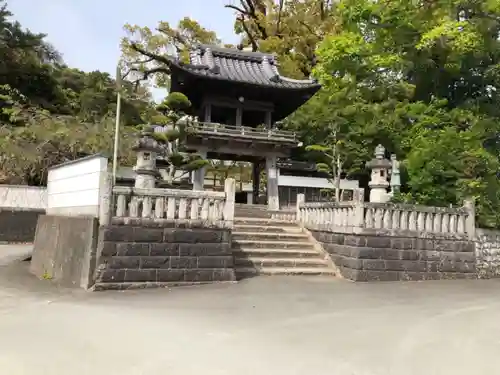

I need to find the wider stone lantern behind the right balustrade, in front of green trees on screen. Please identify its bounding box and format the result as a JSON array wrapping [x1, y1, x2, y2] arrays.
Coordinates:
[[366, 145, 392, 203]]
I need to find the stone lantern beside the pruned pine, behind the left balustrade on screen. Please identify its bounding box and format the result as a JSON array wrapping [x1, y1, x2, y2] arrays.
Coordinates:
[[132, 128, 163, 189]]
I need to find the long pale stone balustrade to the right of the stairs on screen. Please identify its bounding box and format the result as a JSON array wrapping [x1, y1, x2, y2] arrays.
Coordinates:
[[297, 189, 475, 238]]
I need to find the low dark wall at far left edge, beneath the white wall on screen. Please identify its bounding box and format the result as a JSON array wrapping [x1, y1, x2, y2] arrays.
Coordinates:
[[0, 207, 45, 242]]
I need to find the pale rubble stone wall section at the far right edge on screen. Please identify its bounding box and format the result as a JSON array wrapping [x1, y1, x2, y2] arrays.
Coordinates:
[[475, 228, 500, 278]]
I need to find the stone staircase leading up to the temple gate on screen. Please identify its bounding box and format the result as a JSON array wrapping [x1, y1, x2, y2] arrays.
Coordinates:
[[232, 206, 335, 279]]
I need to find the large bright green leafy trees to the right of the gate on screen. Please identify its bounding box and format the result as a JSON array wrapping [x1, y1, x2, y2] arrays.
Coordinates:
[[308, 0, 500, 226]]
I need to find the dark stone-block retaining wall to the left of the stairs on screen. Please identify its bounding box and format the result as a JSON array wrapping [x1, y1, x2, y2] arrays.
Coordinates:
[[95, 218, 235, 290]]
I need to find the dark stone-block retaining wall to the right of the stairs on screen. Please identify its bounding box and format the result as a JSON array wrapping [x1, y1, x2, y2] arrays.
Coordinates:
[[312, 231, 477, 281]]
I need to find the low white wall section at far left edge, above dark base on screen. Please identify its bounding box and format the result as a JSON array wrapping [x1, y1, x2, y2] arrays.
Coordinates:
[[0, 185, 47, 210]]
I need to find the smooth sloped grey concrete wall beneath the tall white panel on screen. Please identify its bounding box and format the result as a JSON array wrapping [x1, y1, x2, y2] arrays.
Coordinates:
[[30, 215, 99, 288]]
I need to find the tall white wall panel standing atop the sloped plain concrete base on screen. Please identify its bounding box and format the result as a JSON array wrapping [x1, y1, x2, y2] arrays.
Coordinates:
[[47, 155, 108, 217]]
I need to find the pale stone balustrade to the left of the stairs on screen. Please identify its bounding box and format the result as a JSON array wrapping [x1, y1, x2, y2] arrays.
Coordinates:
[[109, 179, 234, 223]]
